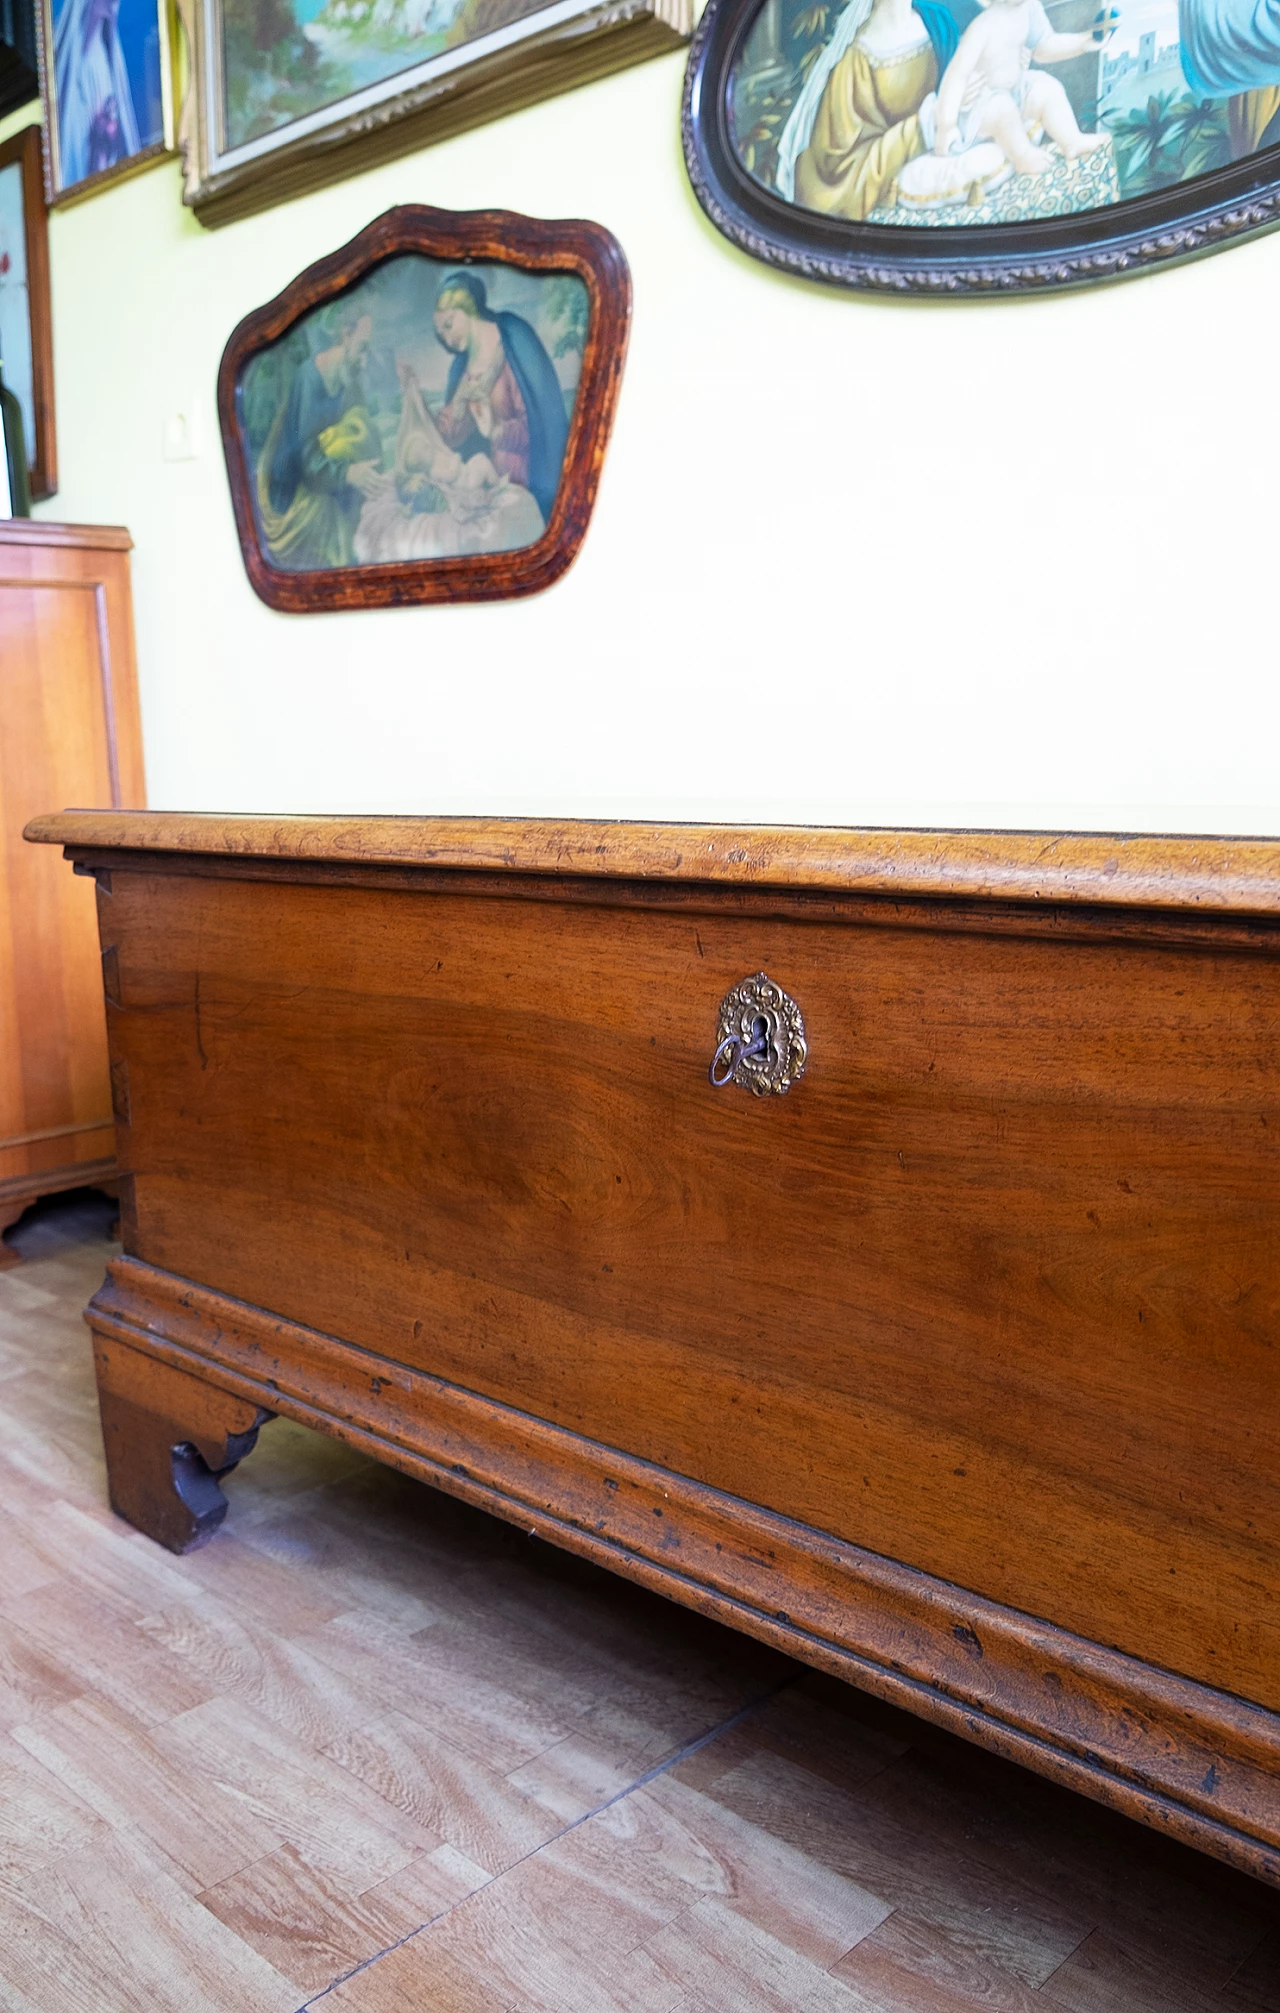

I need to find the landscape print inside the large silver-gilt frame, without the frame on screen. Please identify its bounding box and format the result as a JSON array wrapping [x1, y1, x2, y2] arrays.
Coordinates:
[[219, 0, 547, 149]]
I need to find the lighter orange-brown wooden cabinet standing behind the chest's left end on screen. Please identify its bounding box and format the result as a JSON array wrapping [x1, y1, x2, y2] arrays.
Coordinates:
[[0, 519, 147, 1262]]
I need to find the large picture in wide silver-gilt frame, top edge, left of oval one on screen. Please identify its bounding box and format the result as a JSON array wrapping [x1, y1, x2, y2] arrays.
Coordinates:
[[179, 0, 692, 225]]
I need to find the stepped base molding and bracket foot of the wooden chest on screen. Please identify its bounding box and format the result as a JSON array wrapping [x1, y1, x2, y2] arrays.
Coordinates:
[[85, 1258, 1280, 1886]]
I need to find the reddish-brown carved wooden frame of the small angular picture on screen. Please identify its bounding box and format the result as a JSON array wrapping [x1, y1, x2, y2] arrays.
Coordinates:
[[217, 203, 632, 614]]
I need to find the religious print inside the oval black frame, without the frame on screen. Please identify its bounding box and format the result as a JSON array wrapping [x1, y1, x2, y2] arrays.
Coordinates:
[[729, 0, 1280, 227]]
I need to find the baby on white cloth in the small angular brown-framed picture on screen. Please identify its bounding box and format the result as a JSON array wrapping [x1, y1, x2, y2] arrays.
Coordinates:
[[352, 358, 545, 566]]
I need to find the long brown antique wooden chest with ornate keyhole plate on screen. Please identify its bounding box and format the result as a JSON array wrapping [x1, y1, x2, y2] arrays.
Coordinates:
[[28, 813, 1280, 1882]]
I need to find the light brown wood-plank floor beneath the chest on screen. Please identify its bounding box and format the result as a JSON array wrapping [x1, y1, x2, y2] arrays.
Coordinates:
[[0, 1198, 1280, 2013]]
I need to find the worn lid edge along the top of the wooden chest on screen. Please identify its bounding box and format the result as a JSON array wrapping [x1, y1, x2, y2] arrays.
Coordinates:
[[26, 809, 1280, 918]]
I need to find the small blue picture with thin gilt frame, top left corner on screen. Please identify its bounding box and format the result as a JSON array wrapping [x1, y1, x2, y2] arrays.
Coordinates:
[[38, 0, 175, 203]]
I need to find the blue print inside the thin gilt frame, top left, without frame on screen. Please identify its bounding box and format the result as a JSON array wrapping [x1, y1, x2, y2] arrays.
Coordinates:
[[52, 0, 165, 189]]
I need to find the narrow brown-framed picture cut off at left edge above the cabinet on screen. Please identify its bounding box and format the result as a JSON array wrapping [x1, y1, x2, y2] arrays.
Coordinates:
[[0, 125, 58, 499]]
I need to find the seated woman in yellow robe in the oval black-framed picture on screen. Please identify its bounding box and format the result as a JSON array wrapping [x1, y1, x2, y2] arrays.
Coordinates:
[[777, 0, 978, 221]]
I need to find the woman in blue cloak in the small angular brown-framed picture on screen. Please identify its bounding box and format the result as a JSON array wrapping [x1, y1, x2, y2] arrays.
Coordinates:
[[435, 272, 570, 521]]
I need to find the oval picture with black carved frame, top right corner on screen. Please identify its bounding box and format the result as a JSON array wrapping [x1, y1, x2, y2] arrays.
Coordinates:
[[684, 0, 1280, 296]]
